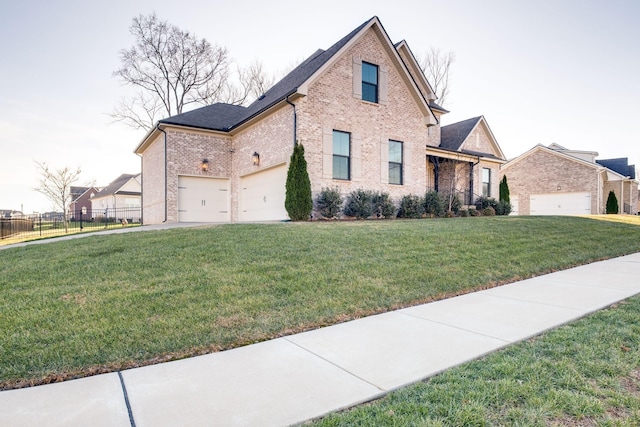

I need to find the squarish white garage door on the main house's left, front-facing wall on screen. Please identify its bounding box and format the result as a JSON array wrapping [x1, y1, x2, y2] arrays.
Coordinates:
[[178, 176, 231, 222]]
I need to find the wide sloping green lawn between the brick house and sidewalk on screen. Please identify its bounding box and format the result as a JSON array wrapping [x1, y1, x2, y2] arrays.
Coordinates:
[[0, 217, 640, 388]]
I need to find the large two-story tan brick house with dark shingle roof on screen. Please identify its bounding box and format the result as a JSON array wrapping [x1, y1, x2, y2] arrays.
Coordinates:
[[135, 17, 506, 224]]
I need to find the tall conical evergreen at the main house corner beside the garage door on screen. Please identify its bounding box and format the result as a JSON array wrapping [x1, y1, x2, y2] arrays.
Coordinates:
[[284, 144, 313, 221]]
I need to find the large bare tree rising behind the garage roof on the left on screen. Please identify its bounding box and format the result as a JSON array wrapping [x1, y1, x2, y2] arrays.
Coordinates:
[[111, 14, 249, 130]]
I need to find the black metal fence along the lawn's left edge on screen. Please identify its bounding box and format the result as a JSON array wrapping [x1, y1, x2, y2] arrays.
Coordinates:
[[0, 208, 142, 243]]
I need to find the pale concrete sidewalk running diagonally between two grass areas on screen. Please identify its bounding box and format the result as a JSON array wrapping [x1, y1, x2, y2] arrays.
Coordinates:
[[0, 253, 640, 427]]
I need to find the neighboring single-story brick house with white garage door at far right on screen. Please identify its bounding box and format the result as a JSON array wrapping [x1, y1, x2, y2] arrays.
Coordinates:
[[499, 144, 638, 215]]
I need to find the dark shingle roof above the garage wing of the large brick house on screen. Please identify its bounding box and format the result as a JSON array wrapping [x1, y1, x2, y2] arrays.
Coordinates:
[[160, 16, 376, 131]]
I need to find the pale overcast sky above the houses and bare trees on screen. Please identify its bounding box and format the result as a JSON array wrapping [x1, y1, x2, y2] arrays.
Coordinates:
[[0, 0, 640, 213]]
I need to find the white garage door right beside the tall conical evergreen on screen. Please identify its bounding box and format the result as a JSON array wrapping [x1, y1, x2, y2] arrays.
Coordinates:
[[239, 165, 289, 221]]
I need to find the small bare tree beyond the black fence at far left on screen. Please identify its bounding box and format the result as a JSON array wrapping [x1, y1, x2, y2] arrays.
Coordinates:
[[34, 161, 81, 233]]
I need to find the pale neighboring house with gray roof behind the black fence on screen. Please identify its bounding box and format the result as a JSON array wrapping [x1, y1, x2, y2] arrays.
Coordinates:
[[91, 174, 142, 222]]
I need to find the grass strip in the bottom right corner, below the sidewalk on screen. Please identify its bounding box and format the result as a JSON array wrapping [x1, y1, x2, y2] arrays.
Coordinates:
[[309, 297, 640, 427]]
